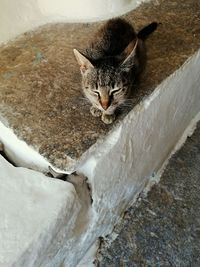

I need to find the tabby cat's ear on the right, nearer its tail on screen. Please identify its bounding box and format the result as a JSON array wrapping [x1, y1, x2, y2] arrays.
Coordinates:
[[120, 39, 138, 68]]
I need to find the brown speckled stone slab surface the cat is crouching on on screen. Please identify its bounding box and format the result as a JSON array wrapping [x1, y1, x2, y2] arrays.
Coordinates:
[[0, 0, 200, 169]]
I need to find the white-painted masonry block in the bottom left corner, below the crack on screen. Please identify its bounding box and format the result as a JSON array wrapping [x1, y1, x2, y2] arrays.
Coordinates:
[[0, 155, 80, 267]]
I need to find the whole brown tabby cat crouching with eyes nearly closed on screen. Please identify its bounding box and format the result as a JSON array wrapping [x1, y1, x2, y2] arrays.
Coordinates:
[[73, 18, 157, 124]]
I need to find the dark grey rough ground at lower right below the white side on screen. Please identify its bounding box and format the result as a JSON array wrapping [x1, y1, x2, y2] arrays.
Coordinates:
[[98, 123, 200, 267]]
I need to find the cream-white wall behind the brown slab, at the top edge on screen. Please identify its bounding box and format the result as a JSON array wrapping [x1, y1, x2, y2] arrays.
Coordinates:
[[0, 0, 147, 43]]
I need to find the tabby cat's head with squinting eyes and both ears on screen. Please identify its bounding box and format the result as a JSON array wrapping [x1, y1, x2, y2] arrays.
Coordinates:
[[74, 42, 137, 114]]
